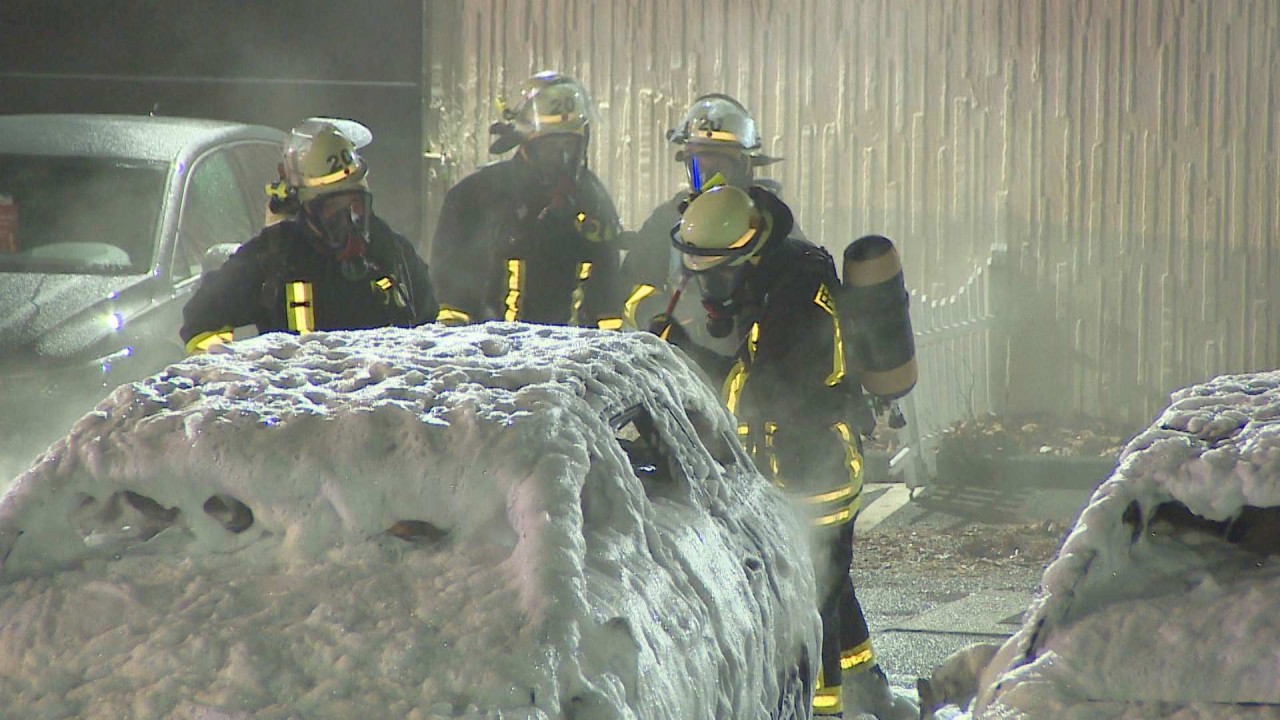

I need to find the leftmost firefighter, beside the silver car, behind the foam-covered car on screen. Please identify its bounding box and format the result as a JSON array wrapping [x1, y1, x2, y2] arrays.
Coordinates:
[[179, 119, 438, 352]]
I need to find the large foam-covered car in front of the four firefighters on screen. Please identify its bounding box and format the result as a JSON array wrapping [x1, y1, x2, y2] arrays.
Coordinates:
[[0, 324, 820, 720]]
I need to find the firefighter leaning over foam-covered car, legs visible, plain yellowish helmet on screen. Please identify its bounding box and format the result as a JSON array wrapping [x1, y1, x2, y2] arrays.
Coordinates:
[[650, 186, 918, 720]]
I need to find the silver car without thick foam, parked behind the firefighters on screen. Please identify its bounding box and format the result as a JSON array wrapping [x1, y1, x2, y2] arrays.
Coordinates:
[[0, 115, 284, 479]]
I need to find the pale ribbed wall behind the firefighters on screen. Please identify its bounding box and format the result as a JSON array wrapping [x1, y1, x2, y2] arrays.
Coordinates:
[[426, 0, 1280, 423]]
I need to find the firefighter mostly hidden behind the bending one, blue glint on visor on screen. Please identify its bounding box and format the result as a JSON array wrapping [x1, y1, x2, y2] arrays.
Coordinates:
[[622, 92, 788, 327]]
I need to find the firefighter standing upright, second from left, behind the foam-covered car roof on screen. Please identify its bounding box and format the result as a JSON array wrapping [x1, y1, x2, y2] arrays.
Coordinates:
[[430, 72, 622, 329]]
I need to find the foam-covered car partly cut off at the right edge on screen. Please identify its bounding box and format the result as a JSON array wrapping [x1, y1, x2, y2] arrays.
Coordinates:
[[973, 372, 1280, 720]]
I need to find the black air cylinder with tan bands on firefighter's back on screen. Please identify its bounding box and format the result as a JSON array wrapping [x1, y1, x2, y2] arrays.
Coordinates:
[[840, 236, 916, 400]]
